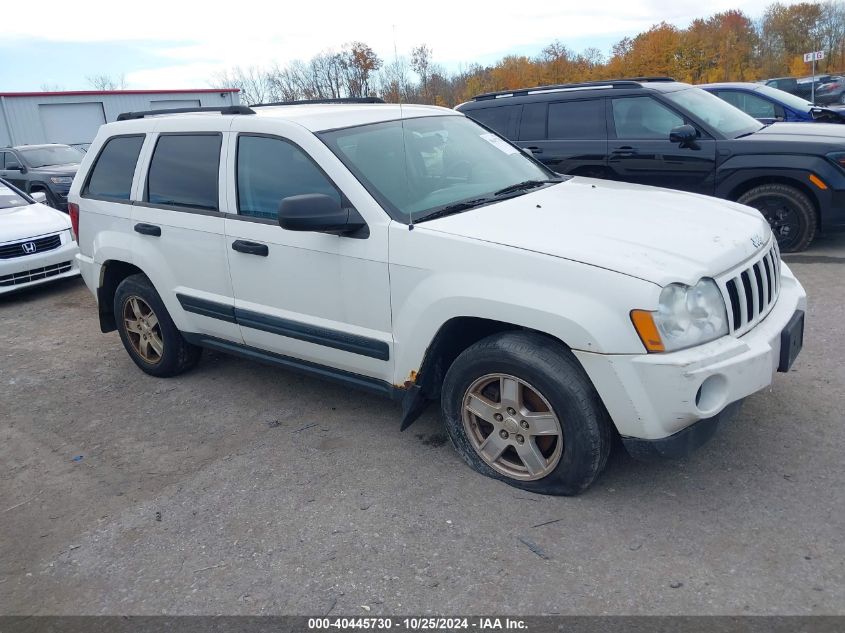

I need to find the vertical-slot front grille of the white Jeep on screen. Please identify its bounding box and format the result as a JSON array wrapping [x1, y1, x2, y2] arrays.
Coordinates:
[[717, 239, 780, 336]]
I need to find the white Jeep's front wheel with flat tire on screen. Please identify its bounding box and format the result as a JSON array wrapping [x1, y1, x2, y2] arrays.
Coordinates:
[[441, 331, 612, 495]]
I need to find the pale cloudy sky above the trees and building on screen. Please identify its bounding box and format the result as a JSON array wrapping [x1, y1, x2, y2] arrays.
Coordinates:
[[0, 0, 791, 92]]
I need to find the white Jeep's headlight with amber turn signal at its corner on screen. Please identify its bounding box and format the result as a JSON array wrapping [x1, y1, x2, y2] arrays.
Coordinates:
[[631, 279, 728, 352]]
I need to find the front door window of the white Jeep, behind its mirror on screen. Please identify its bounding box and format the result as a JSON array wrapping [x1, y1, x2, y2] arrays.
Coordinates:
[[237, 135, 341, 220]]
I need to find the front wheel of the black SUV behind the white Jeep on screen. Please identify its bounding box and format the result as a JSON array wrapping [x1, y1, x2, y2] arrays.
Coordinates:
[[737, 183, 818, 253]]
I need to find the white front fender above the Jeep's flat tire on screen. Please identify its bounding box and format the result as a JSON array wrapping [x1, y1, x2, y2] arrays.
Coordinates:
[[390, 231, 660, 384]]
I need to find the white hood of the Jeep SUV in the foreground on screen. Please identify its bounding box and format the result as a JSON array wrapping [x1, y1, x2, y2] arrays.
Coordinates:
[[418, 177, 772, 286]]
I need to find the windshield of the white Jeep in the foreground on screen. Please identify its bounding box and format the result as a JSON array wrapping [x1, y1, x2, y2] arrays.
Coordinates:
[[320, 115, 559, 222]]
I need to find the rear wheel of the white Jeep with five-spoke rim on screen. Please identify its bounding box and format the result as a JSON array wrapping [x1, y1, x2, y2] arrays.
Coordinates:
[[114, 274, 202, 378]]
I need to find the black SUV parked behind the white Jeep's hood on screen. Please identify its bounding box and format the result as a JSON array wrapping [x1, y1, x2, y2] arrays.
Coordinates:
[[457, 77, 845, 252]]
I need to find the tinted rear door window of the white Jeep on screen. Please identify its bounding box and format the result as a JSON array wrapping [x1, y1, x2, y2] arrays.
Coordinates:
[[147, 134, 222, 211]]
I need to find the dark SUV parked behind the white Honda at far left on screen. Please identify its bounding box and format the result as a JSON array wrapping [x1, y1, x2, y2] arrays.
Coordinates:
[[0, 144, 85, 211]]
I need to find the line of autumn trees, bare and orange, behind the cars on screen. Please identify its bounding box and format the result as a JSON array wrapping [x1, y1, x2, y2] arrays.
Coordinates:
[[209, 0, 845, 107]]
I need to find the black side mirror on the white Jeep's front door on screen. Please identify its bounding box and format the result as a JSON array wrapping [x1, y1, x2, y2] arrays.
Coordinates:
[[279, 193, 369, 237]]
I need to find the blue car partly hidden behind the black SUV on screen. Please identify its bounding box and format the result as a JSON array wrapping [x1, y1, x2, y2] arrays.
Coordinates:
[[699, 82, 845, 123]]
